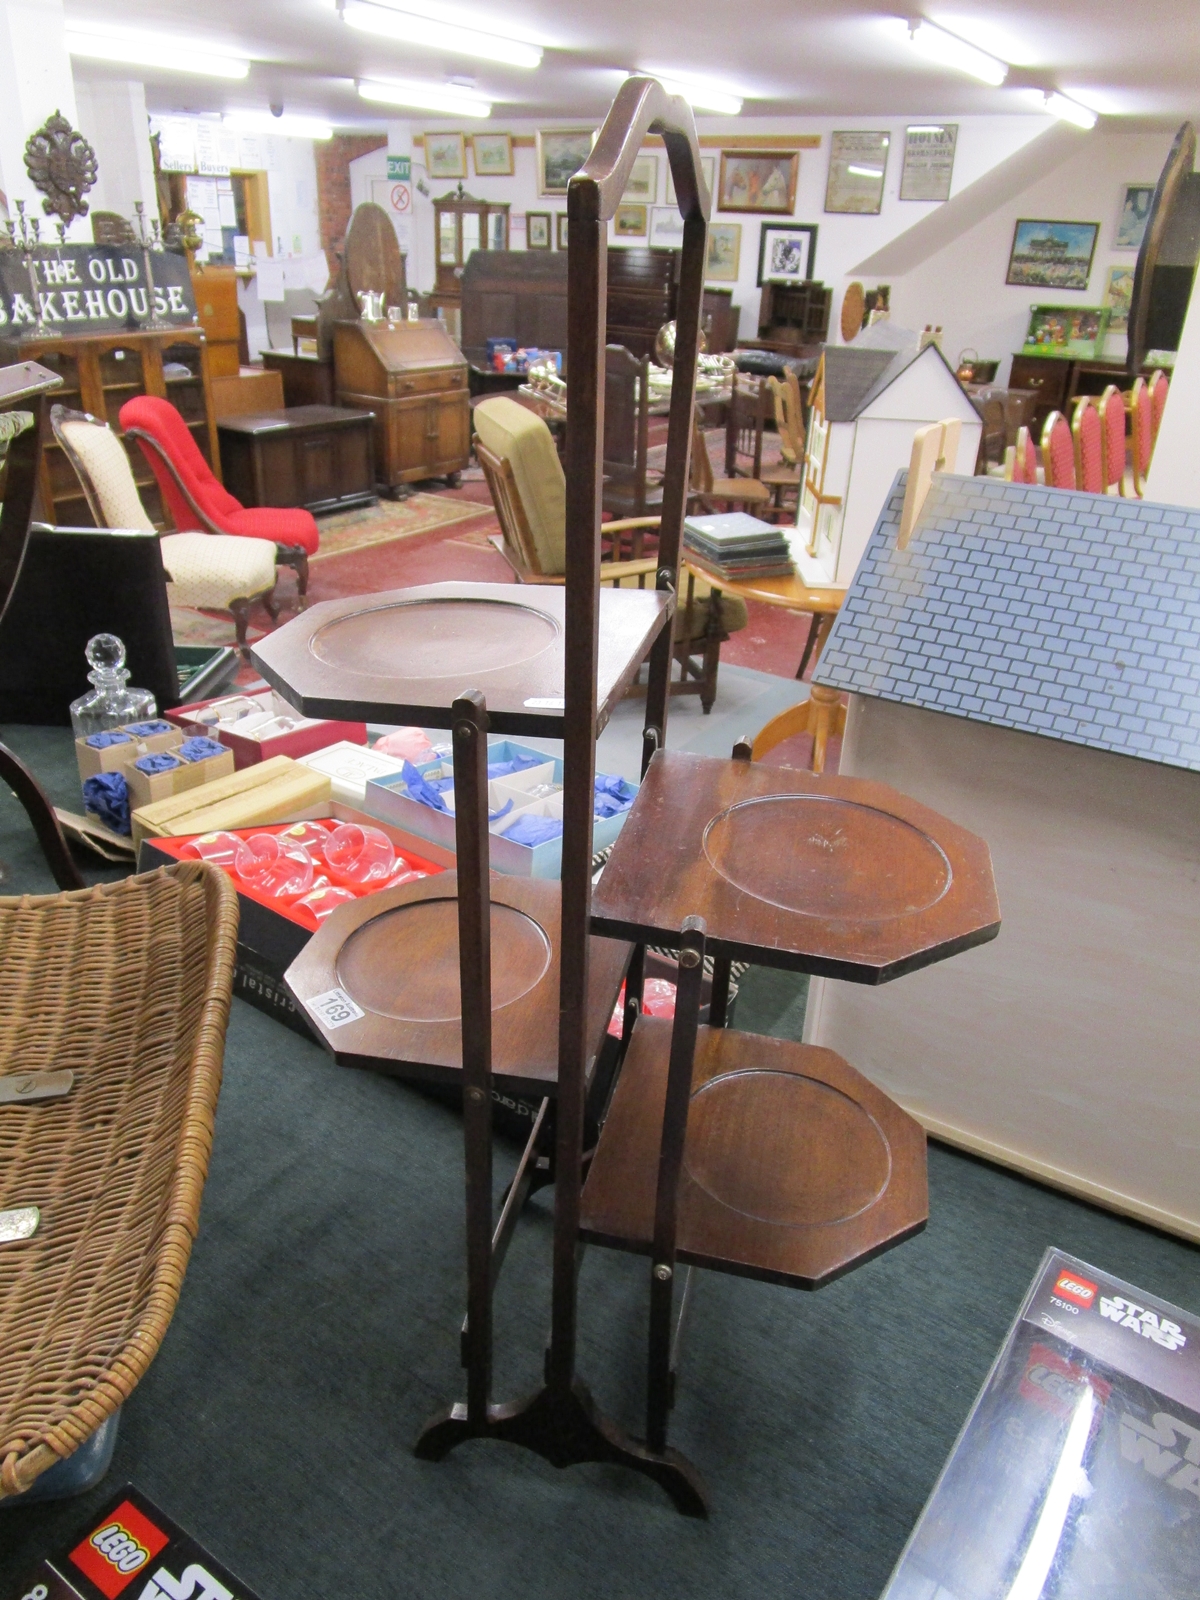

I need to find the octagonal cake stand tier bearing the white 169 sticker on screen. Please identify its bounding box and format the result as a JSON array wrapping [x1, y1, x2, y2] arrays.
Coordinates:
[[285, 872, 630, 1096]]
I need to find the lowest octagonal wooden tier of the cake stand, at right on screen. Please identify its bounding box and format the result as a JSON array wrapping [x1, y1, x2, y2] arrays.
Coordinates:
[[579, 1016, 930, 1290]]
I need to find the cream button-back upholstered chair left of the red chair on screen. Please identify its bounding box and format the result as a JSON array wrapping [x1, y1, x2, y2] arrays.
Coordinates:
[[50, 405, 278, 653]]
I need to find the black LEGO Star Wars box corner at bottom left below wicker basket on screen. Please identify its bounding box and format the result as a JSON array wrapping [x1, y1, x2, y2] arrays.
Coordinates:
[[3, 1485, 258, 1600]]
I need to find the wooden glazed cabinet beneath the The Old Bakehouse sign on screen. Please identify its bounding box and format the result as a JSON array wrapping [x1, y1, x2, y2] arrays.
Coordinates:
[[0, 328, 221, 528]]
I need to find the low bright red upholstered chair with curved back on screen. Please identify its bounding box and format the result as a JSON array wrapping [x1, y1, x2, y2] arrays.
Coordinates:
[[120, 395, 320, 595]]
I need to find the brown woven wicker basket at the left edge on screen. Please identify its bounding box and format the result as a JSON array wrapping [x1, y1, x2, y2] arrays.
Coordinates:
[[0, 861, 237, 1498]]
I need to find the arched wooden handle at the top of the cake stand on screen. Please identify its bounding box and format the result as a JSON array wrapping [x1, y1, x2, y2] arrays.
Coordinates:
[[566, 78, 712, 222]]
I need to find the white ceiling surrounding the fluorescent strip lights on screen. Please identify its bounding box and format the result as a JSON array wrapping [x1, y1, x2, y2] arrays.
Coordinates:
[[67, 0, 1200, 128]]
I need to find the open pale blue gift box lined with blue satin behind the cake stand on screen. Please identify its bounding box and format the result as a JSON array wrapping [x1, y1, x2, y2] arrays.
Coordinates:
[[363, 739, 626, 878]]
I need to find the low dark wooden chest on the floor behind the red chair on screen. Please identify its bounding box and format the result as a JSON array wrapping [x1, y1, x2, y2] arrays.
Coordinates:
[[218, 405, 376, 512]]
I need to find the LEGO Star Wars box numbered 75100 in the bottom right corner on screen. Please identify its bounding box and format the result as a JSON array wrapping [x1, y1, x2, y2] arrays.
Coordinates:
[[883, 1250, 1200, 1600]]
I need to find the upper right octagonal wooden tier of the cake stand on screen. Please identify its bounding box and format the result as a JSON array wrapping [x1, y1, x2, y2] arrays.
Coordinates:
[[592, 752, 1000, 984]]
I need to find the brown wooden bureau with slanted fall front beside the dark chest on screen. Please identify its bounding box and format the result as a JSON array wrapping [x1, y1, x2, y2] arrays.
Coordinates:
[[333, 320, 470, 490]]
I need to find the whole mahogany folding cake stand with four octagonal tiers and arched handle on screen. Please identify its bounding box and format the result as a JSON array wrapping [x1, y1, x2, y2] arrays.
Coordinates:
[[254, 78, 998, 1515]]
